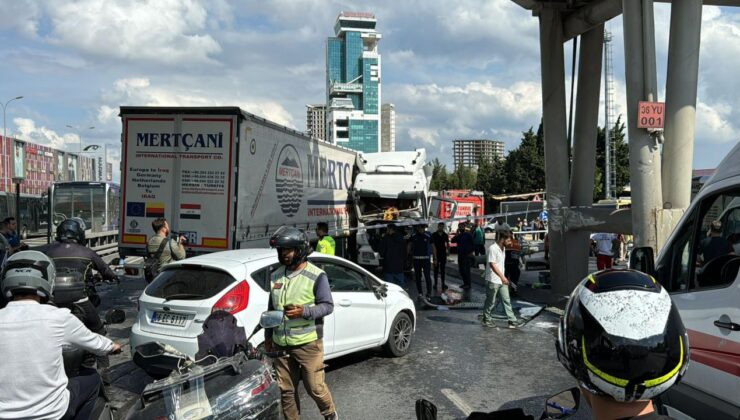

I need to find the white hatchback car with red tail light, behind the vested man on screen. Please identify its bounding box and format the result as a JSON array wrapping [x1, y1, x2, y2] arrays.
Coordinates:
[[130, 249, 416, 359]]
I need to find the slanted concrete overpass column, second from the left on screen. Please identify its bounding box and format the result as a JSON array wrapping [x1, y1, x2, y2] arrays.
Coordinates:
[[566, 24, 604, 283]]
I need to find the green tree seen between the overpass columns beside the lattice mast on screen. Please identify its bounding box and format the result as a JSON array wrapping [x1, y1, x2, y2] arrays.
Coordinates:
[[594, 116, 630, 201]]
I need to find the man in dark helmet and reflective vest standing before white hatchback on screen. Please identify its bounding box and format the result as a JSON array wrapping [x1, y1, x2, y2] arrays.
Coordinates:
[[265, 226, 338, 420]]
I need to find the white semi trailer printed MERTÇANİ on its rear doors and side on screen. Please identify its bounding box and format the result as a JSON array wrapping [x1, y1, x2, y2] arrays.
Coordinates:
[[118, 107, 356, 257]]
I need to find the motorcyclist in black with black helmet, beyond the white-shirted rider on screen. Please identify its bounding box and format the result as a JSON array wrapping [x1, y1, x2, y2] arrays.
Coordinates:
[[39, 217, 116, 370]]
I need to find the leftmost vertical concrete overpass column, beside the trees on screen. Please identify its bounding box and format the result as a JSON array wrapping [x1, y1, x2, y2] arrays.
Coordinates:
[[539, 7, 573, 293]]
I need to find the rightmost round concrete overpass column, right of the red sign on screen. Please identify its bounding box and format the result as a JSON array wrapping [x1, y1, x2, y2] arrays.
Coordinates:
[[663, 0, 702, 211]]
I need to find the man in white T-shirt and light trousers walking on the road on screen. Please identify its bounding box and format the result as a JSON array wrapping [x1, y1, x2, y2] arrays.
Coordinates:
[[480, 232, 521, 328]]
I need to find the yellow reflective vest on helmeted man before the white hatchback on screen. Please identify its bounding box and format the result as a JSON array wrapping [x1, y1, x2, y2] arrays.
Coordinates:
[[270, 263, 323, 347]]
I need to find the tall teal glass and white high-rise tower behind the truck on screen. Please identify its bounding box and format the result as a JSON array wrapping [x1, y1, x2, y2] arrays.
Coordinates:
[[326, 12, 381, 153]]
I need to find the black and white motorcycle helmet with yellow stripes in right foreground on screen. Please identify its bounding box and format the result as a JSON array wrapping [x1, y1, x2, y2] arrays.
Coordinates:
[[556, 270, 689, 402]]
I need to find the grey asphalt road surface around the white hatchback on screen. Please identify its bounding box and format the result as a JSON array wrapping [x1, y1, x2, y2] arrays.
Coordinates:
[[92, 260, 590, 420]]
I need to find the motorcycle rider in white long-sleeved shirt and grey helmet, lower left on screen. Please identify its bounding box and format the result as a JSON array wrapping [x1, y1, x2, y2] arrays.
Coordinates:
[[0, 251, 121, 419]]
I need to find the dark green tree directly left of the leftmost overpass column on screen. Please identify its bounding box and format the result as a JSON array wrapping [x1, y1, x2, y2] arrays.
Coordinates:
[[505, 123, 545, 194]]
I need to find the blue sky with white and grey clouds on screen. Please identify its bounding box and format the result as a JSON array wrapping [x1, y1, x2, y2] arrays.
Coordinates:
[[0, 0, 740, 182]]
